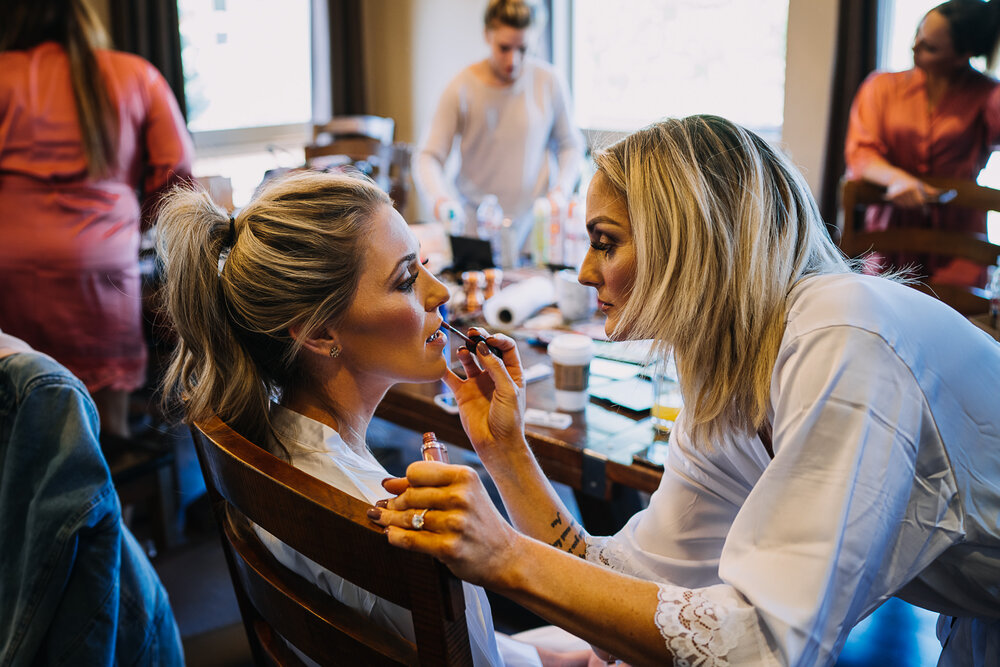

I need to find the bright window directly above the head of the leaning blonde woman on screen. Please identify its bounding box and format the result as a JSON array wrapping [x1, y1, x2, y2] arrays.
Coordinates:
[[570, 0, 788, 140]]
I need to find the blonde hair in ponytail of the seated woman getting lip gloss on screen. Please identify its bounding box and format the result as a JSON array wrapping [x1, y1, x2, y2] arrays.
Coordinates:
[[158, 172, 392, 454]]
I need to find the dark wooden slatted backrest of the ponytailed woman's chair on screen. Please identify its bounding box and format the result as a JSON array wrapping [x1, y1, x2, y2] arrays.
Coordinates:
[[191, 418, 472, 665]]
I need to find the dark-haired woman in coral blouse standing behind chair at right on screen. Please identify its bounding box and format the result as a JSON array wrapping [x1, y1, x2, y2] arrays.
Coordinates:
[[845, 0, 1000, 284]]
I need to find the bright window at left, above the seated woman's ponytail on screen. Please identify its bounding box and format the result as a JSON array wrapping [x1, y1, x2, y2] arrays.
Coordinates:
[[177, 0, 313, 206]]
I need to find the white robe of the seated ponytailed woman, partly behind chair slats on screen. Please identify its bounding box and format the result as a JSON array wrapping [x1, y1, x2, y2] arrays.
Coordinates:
[[254, 405, 541, 667]]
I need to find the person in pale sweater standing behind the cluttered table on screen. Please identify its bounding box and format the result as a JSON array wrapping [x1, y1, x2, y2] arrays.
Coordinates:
[[414, 0, 583, 252]]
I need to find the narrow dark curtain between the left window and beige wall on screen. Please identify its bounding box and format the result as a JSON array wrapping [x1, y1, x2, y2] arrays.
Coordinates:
[[327, 0, 368, 116]]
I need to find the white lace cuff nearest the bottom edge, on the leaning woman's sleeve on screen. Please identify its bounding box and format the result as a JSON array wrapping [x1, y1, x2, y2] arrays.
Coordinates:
[[655, 584, 748, 667]]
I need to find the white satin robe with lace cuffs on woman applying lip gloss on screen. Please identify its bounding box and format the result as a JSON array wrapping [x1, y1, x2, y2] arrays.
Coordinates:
[[587, 274, 1000, 665]]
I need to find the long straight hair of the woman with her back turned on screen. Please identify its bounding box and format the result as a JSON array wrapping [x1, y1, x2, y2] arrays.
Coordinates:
[[0, 0, 118, 179]]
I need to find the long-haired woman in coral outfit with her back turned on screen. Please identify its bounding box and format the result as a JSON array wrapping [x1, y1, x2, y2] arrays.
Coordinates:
[[0, 0, 193, 442]]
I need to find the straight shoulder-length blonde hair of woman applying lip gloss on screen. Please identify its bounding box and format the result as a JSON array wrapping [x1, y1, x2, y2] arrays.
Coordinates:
[[595, 116, 851, 447]]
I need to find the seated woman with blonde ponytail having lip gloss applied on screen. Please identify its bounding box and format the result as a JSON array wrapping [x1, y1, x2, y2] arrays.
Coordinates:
[[159, 172, 586, 665]]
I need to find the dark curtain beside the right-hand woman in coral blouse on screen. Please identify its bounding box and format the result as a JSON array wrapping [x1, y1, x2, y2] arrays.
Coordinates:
[[819, 0, 880, 239]]
